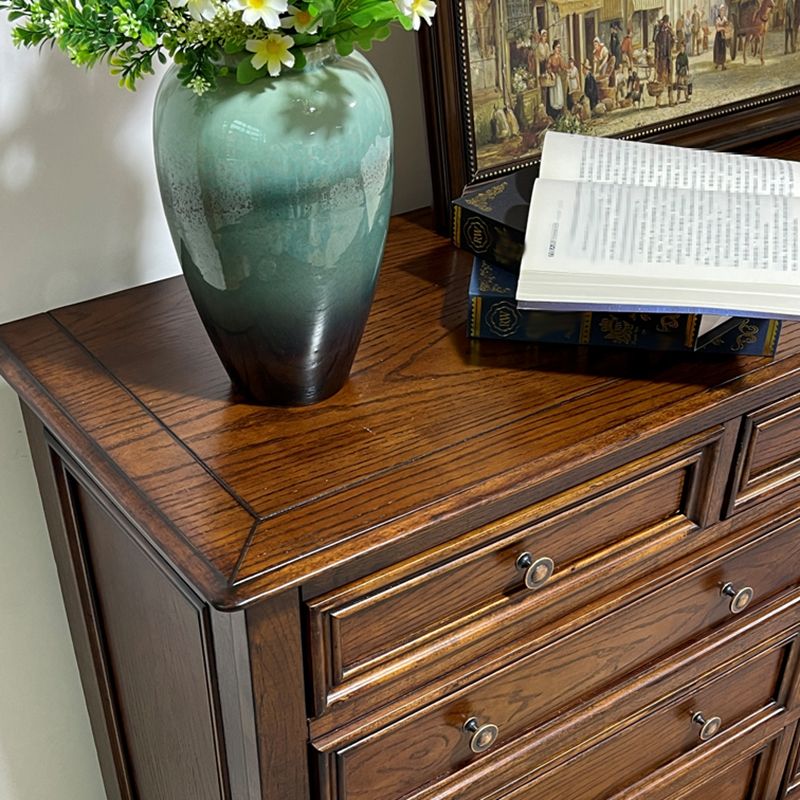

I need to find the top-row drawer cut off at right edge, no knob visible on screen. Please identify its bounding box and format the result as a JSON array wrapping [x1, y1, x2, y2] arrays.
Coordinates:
[[728, 396, 800, 514]]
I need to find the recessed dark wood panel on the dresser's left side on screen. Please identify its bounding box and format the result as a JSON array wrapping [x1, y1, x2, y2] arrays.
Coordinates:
[[73, 476, 226, 800]]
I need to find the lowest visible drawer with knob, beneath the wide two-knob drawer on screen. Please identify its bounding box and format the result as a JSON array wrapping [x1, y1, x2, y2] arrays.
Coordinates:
[[504, 648, 786, 800]]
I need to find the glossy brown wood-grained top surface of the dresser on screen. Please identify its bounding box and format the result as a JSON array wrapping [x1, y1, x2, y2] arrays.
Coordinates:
[[0, 215, 800, 607]]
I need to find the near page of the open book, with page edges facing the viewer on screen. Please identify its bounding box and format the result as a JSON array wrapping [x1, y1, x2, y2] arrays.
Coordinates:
[[517, 178, 800, 318]]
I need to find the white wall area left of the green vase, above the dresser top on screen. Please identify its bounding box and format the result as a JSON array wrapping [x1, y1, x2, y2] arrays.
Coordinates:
[[0, 21, 177, 321]]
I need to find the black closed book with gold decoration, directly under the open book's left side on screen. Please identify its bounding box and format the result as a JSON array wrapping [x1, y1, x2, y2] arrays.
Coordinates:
[[452, 167, 534, 272]]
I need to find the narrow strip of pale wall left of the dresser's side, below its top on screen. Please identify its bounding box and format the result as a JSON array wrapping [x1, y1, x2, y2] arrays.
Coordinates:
[[0, 380, 105, 800]]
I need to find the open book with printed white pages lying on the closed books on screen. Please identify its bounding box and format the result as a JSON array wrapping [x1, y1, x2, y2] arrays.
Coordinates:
[[517, 132, 800, 331]]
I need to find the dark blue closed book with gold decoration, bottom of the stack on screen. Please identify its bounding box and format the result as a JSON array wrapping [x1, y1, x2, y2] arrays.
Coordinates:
[[468, 258, 781, 356]]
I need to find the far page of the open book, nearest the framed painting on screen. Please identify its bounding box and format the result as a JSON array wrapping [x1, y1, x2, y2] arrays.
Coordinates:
[[539, 131, 800, 197]]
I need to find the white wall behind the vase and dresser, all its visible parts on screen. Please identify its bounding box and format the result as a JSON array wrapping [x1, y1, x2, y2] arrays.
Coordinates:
[[0, 18, 430, 800]]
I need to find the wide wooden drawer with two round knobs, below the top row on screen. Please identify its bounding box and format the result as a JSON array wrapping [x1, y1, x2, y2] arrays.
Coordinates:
[[317, 521, 800, 800]]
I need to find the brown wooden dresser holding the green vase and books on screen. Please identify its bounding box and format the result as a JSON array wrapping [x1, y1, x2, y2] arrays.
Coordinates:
[[0, 209, 800, 800]]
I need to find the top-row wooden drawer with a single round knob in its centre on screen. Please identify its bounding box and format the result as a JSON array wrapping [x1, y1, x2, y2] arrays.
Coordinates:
[[308, 428, 723, 714]]
